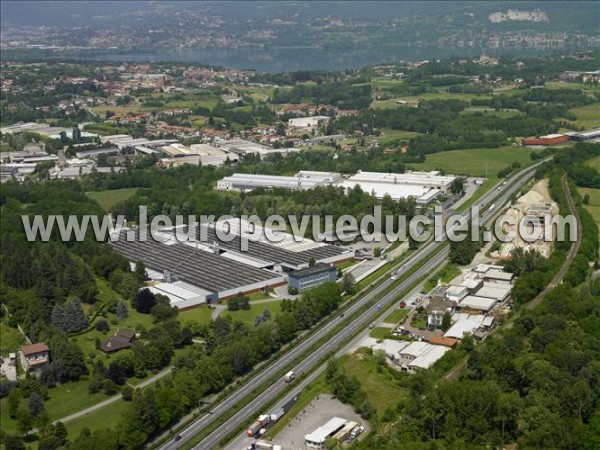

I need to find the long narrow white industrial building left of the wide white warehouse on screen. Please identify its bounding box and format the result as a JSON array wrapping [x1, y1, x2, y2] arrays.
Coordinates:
[[217, 170, 342, 192]]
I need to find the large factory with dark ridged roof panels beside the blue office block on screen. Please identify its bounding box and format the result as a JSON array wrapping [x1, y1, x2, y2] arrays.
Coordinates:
[[110, 221, 353, 309]]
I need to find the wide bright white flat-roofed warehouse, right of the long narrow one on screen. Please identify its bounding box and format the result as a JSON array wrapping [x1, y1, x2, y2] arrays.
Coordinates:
[[342, 171, 456, 204]]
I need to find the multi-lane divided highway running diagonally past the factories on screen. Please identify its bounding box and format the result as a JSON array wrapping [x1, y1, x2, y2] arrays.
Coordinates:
[[160, 161, 545, 450]]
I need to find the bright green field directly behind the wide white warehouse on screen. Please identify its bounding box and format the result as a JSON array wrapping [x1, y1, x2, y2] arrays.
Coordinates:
[[411, 147, 532, 177]]
